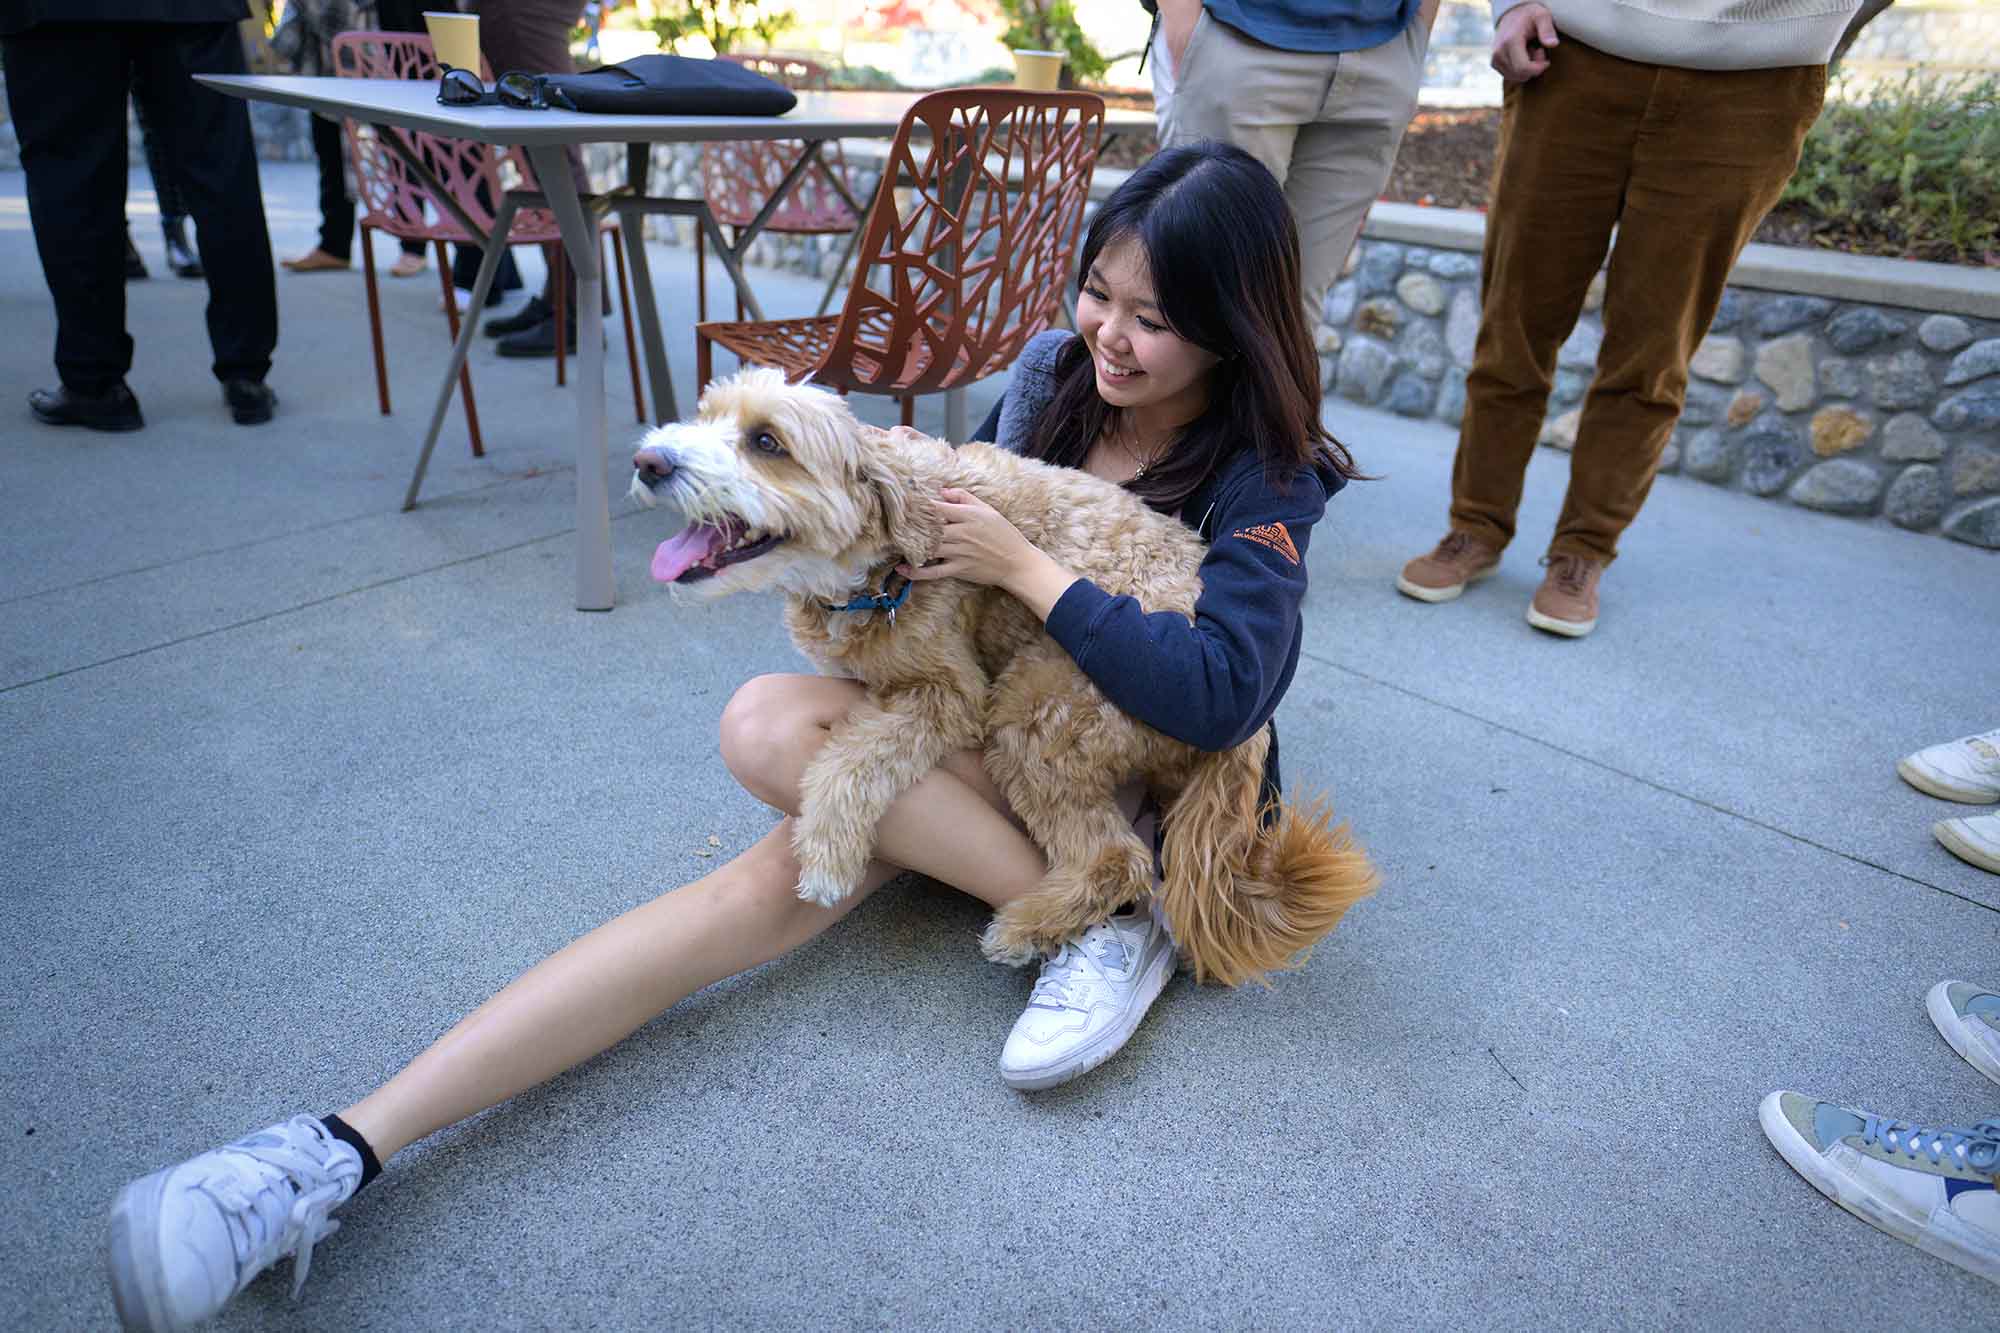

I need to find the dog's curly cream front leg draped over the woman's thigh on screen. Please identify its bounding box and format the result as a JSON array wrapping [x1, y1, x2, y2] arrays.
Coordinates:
[[792, 679, 984, 907]]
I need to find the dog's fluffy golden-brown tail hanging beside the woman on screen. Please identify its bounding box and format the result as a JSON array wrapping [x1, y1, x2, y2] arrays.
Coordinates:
[[1160, 735, 1380, 987]]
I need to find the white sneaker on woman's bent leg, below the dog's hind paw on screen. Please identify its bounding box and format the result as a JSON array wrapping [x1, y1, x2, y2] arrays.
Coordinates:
[[1000, 892, 1174, 1089]]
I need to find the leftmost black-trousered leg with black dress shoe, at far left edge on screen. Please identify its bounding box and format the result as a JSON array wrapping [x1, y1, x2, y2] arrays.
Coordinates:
[[0, 24, 144, 430]]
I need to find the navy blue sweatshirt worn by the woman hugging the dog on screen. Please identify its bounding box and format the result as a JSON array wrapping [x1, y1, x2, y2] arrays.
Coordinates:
[[980, 330, 1346, 752]]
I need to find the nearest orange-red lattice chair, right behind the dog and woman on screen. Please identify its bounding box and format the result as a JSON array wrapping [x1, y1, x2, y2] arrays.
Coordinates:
[[694, 88, 1104, 424]]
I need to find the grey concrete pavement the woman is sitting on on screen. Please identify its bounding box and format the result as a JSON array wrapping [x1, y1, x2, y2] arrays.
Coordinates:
[[0, 164, 2000, 1329]]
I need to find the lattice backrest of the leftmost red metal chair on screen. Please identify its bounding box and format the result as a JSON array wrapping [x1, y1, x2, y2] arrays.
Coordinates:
[[334, 32, 520, 240]]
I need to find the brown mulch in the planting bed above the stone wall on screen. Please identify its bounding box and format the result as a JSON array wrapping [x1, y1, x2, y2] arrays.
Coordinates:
[[1102, 98, 1904, 258]]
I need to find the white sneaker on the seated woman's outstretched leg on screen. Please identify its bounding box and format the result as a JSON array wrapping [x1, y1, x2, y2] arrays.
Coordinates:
[[106, 1115, 362, 1331]]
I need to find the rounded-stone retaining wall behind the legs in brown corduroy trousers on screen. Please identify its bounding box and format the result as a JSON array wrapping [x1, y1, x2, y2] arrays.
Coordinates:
[[1320, 226, 2000, 548]]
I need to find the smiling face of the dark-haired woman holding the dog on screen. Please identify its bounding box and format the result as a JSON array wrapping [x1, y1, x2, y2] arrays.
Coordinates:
[[1076, 236, 1222, 426]]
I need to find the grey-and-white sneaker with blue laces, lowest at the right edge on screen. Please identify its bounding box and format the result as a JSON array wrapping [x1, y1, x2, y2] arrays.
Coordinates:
[[1758, 1093, 2000, 1283]]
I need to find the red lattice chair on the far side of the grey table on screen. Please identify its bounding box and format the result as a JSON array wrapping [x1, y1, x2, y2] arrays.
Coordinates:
[[694, 56, 862, 320]]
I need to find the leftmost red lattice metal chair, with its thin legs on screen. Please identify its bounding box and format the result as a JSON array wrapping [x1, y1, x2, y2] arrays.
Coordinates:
[[334, 32, 646, 458]]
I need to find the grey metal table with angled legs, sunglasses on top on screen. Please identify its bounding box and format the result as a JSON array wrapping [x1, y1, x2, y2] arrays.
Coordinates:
[[196, 74, 1152, 610]]
